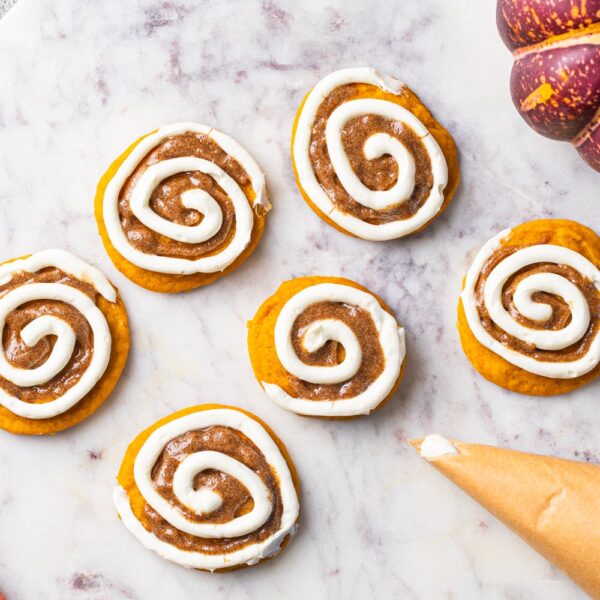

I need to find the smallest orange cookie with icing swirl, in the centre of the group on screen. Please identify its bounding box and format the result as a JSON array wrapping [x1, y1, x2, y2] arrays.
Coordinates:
[[248, 277, 406, 417]]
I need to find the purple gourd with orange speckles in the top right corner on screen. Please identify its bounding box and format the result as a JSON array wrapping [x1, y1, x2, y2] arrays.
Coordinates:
[[496, 0, 600, 171]]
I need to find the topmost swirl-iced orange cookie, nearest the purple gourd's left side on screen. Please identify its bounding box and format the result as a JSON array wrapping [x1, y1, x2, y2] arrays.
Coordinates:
[[292, 68, 460, 241]]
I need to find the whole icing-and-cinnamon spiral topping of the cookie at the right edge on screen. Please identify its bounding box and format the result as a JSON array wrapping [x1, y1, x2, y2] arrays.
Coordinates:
[[461, 230, 600, 379]]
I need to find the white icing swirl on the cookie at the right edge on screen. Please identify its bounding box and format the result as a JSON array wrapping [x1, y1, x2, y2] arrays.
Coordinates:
[[461, 229, 600, 379]]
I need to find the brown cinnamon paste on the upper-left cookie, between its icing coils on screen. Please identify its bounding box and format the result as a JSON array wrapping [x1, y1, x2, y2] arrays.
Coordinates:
[[119, 132, 251, 260]]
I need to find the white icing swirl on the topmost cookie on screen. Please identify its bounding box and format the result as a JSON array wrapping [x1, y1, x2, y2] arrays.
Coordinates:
[[292, 68, 448, 241]]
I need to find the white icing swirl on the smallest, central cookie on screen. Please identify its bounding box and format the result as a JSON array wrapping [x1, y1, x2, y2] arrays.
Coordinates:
[[261, 283, 406, 417]]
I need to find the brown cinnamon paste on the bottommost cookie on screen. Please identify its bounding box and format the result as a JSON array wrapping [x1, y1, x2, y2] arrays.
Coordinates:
[[144, 426, 282, 554]]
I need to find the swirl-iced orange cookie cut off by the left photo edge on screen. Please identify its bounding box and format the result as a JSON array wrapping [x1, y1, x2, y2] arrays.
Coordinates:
[[0, 250, 129, 434]]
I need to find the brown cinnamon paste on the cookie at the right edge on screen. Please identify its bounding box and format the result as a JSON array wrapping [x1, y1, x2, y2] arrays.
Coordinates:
[[475, 246, 600, 362]]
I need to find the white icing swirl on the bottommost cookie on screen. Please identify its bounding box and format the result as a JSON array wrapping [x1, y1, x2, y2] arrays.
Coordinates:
[[114, 408, 299, 571]]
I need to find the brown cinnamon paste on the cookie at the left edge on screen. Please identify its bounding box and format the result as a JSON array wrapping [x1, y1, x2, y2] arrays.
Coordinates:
[[0, 267, 97, 403]]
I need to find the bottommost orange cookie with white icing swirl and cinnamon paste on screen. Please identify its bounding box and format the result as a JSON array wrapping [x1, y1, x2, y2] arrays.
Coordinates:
[[114, 404, 299, 571]]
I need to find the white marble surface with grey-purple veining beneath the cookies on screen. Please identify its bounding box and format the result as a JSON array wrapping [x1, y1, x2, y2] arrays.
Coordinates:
[[0, 0, 600, 600]]
